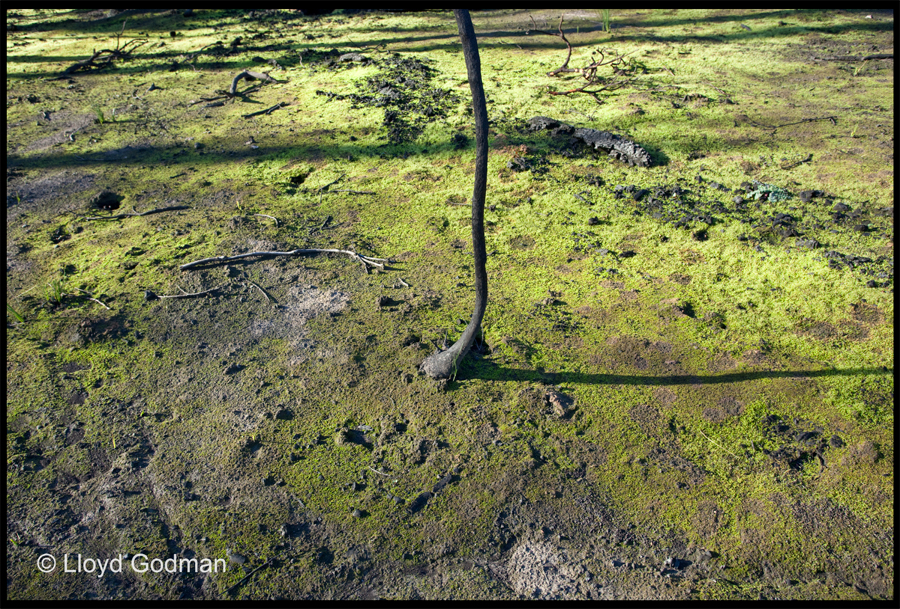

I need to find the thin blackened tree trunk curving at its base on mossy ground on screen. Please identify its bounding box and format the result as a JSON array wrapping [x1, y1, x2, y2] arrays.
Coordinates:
[[421, 9, 488, 378]]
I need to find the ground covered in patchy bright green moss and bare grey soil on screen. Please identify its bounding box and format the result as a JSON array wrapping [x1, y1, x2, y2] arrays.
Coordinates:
[[6, 10, 894, 599]]
